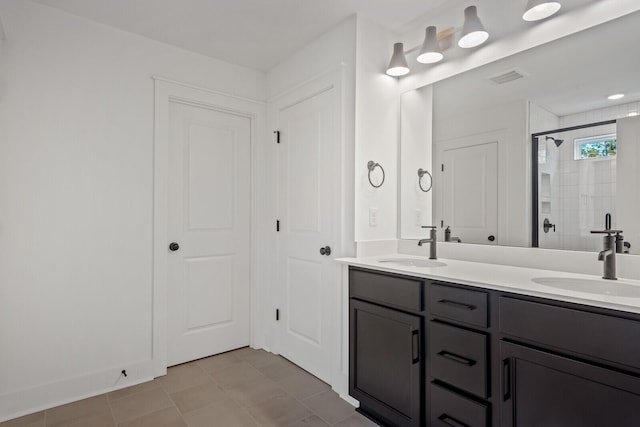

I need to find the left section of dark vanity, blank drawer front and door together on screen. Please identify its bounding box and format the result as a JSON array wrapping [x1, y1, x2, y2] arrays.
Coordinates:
[[349, 268, 424, 427]]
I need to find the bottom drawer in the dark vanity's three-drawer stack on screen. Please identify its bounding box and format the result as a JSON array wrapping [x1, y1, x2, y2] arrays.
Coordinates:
[[429, 384, 489, 427]]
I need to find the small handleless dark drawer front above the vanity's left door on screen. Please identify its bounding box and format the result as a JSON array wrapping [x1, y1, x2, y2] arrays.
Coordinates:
[[349, 269, 424, 311]]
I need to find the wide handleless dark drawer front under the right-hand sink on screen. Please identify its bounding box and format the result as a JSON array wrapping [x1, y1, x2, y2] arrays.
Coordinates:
[[499, 298, 640, 369]]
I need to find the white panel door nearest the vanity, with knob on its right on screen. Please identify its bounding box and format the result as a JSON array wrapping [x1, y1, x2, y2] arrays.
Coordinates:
[[277, 89, 339, 381]]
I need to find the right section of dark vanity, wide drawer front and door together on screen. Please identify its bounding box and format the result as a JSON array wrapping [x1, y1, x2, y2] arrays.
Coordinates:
[[500, 297, 640, 427]]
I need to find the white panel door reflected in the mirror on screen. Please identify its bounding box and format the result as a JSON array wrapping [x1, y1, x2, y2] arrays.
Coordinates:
[[442, 142, 498, 245]]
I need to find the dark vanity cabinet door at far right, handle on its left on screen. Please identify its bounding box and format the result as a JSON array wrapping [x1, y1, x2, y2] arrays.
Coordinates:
[[500, 341, 640, 427]]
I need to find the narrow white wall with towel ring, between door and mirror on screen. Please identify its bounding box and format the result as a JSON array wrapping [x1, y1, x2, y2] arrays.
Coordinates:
[[355, 17, 400, 241]]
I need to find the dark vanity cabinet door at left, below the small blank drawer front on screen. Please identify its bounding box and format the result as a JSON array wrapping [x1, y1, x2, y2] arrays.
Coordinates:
[[349, 299, 424, 426]]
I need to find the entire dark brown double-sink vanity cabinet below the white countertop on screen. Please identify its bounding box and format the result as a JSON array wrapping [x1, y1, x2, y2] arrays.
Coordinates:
[[349, 267, 640, 427]]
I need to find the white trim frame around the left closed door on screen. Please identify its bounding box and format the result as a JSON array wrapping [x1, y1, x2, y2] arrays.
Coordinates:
[[151, 76, 266, 377]]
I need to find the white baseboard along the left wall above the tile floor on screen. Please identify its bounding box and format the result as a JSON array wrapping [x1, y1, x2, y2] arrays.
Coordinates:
[[0, 360, 154, 422]]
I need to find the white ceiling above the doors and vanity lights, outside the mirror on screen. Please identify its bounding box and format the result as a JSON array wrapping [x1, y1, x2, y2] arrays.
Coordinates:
[[33, 0, 596, 71]]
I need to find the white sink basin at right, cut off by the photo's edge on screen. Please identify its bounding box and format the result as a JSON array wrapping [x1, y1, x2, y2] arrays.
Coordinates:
[[532, 277, 640, 298]]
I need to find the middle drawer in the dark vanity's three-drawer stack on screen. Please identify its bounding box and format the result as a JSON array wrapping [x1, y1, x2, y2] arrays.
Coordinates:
[[429, 322, 488, 398]]
